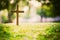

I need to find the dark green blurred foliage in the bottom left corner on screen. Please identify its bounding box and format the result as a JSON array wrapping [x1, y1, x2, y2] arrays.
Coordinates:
[[0, 24, 10, 40]]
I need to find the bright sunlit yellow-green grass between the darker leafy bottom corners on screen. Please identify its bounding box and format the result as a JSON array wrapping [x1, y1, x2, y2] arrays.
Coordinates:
[[0, 23, 60, 40]]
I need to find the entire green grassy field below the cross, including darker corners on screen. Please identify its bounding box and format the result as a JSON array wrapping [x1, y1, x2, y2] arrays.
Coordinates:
[[0, 23, 60, 40]]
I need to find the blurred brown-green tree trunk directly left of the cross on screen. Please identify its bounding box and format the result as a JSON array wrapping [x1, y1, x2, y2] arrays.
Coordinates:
[[8, 0, 20, 22]]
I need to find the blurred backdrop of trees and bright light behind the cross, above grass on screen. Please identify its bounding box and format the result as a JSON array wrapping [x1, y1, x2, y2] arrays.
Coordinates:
[[0, 0, 60, 23]]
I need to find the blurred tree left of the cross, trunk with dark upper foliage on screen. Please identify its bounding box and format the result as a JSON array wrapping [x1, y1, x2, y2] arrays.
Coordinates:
[[0, 0, 20, 22]]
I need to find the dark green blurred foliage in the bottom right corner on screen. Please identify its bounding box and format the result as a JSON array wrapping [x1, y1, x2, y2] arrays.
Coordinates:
[[37, 24, 60, 40]]
